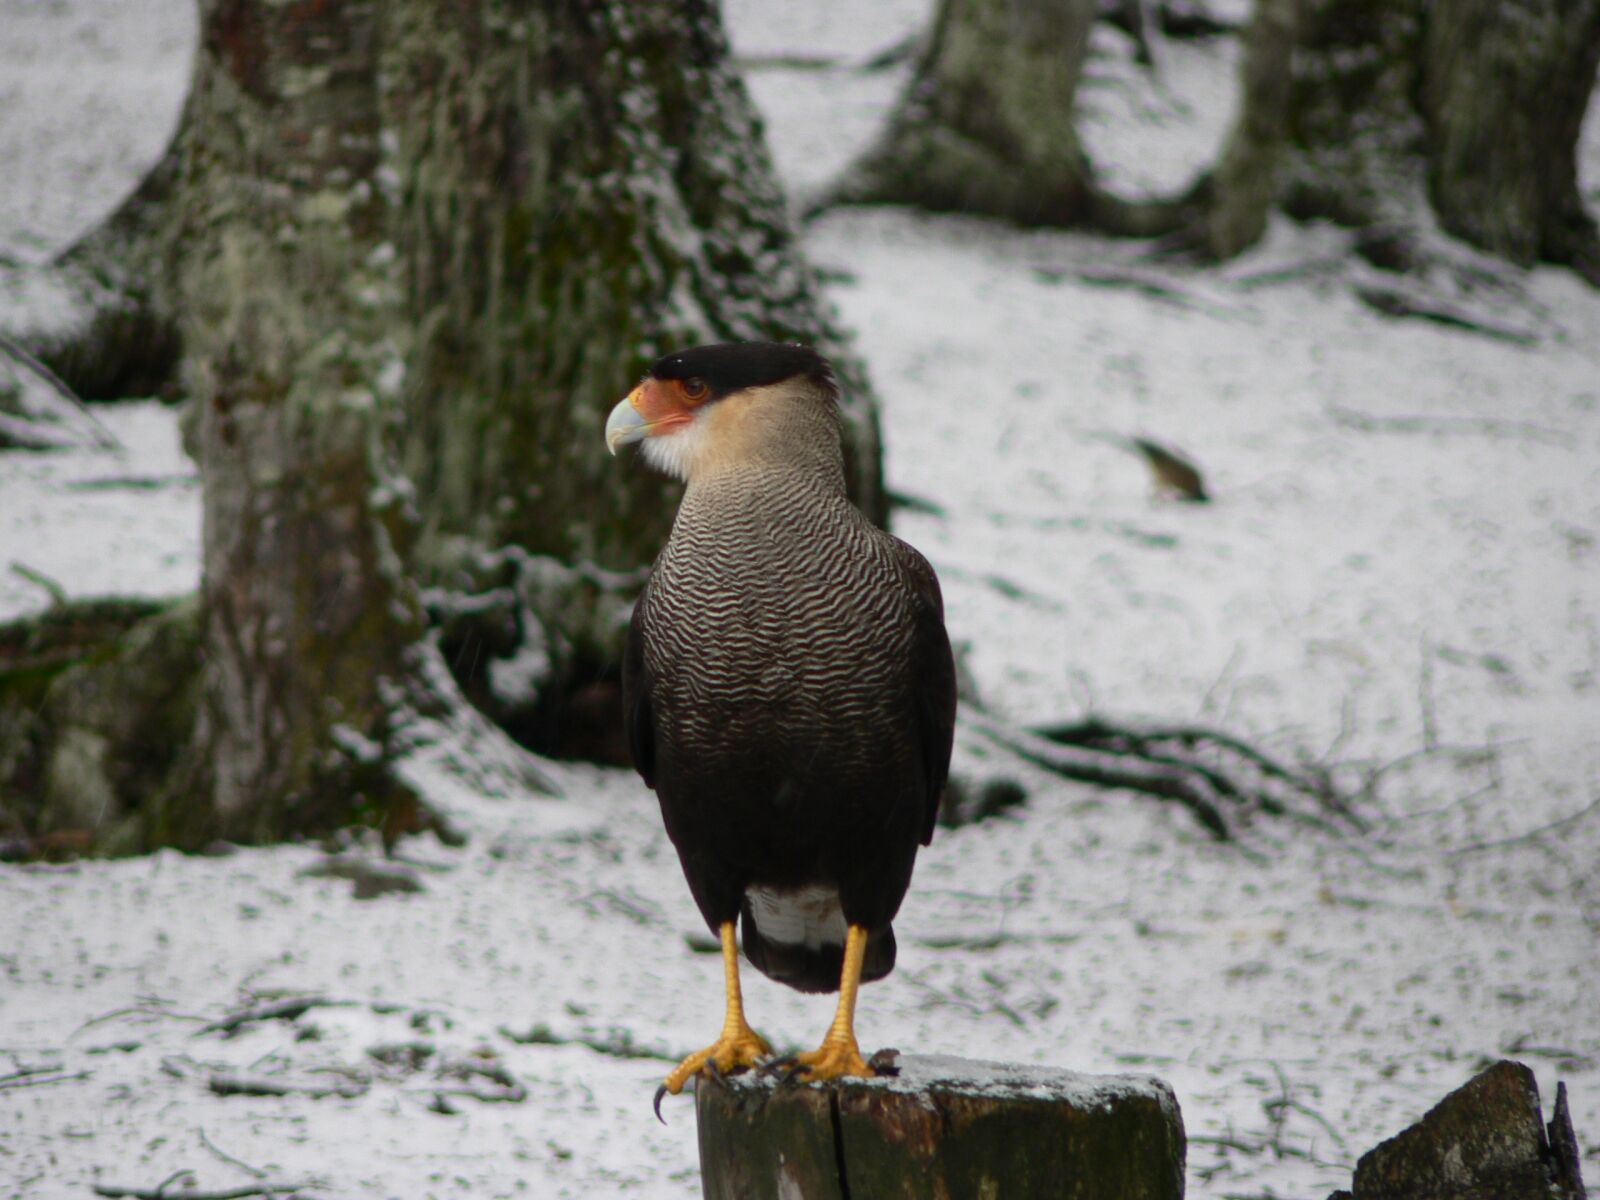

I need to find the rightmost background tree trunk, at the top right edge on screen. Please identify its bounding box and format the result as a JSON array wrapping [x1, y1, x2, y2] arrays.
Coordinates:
[[1421, 0, 1600, 286]]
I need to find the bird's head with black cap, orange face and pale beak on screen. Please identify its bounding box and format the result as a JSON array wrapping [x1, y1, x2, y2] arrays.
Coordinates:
[[605, 342, 843, 480]]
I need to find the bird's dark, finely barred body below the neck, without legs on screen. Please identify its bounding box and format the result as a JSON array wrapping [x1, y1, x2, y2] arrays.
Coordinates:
[[624, 448, 954, 990]]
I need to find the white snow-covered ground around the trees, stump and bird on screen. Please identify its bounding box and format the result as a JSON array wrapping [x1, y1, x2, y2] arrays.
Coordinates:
[[0, 0, 1600, 1200]]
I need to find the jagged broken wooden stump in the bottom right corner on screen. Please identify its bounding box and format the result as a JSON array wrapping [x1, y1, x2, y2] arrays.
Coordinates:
[[1328, 1061, 1584, 1200]]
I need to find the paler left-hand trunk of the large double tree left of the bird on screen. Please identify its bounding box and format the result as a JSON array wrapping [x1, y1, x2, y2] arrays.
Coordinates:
[[173, 0, 422, 840]]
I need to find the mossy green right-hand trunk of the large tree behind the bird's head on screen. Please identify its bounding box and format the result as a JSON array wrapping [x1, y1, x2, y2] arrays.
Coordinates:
[[384, 0, 885, 573]]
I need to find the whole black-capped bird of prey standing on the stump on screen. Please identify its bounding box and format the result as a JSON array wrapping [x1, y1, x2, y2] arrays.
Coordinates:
[[605, 342, 955, 1117]]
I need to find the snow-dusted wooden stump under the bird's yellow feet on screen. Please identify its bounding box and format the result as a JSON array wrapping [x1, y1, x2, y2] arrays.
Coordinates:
[[694, 1056, 1186, 1200]]
